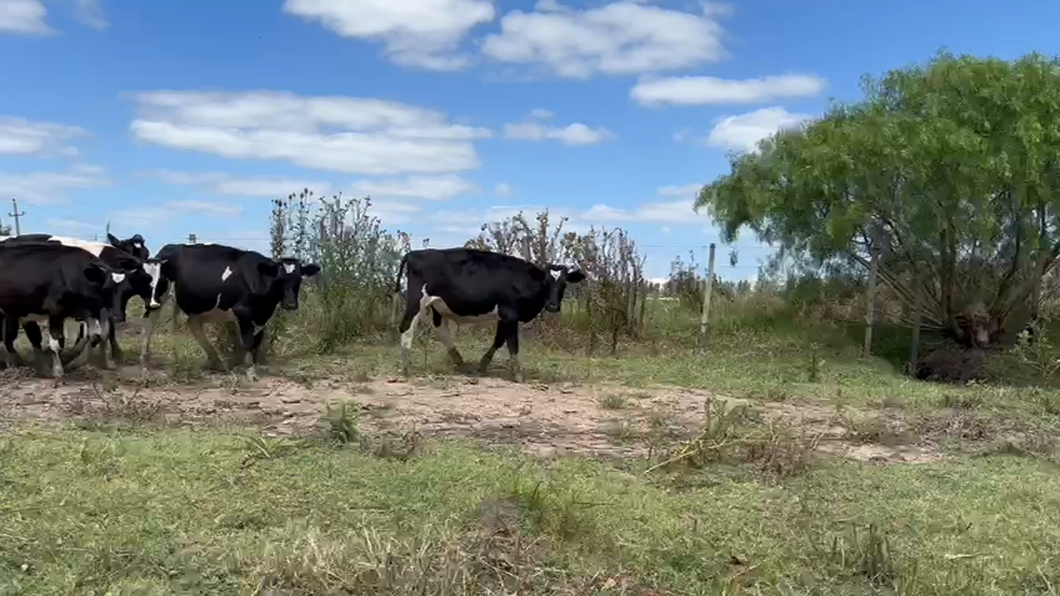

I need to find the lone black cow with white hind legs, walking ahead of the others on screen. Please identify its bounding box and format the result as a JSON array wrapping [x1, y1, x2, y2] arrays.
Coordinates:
[[394, 248, 585, 381]]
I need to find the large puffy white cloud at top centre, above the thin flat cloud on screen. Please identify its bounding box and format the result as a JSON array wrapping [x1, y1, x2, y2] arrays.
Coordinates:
[[482, 0, 725, 78]]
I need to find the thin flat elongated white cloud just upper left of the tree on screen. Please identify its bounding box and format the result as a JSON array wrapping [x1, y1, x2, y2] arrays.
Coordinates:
[[630, 74, 825, 106]]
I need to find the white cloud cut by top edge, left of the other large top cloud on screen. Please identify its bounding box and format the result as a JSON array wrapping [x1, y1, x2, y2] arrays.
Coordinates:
[[283, 0, 495, 70]]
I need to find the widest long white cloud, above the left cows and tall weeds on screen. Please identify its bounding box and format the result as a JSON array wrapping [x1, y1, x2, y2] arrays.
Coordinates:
[[130, 90, 491, 175]]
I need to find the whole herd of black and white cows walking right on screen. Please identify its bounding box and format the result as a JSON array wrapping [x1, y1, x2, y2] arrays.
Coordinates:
[[0, 233, 584, 380]]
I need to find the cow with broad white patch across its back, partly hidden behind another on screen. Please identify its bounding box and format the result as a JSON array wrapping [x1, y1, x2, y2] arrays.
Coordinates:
[[0, 233, 161, 368]]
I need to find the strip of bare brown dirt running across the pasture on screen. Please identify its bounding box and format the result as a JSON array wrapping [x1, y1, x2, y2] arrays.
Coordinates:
[[0, 368, 939, 463]]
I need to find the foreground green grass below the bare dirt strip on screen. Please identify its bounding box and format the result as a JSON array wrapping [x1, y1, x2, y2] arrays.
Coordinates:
[[0, 419, 1060, 595]]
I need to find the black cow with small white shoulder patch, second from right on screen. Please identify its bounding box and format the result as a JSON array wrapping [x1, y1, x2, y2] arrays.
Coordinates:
[[140, 244, 320, 380]]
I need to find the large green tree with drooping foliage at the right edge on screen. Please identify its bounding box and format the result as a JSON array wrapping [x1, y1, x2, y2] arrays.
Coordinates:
[[695, 53, 1060, 345]]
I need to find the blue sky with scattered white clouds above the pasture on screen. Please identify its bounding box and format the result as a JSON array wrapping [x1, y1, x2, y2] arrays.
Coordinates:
[[0, 0, 1060, 278]]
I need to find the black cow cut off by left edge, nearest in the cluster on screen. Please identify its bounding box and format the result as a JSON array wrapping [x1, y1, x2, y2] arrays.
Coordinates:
[[0, 242, 125, 379]]
